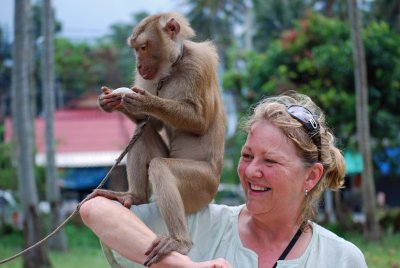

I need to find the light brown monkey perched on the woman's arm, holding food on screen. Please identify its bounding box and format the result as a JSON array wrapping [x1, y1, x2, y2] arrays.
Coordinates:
[[94, 13, 226, 266]]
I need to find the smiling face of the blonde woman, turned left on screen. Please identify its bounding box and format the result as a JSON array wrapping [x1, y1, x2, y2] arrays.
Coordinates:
[[238, 120, 310, 218]]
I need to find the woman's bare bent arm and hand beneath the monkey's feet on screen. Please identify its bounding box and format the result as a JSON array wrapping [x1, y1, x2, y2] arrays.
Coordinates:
[[80, 197, 231, 268]]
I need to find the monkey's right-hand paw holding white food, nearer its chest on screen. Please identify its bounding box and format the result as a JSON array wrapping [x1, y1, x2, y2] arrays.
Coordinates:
[[122, 87, 153, 114]]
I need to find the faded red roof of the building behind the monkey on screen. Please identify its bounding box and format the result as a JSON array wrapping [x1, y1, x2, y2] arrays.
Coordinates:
[[5, 108, 134, 154]]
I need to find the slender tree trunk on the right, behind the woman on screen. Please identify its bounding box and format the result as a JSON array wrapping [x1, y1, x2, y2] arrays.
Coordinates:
[[348, 0, 380, 241]]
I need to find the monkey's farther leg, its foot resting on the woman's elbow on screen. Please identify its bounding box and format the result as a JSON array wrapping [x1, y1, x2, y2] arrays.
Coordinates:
[[89, 123, 168, 208]]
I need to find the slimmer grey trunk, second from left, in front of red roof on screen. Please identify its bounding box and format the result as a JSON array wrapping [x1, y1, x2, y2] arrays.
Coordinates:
[[41, 0, 67, 251]]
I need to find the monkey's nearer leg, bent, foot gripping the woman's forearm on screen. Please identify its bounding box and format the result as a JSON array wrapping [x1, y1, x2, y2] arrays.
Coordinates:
[[145, 158, 219, 266]]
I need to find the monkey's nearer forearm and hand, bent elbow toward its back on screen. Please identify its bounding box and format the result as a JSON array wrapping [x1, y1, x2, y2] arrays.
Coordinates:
[[122, 87, 213, 134]]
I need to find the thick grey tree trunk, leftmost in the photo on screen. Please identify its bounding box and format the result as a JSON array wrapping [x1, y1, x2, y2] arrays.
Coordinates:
[[12, 0, 50, 268]]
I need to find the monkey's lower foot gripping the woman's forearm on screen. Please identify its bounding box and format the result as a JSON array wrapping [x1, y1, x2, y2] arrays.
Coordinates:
[[143, 236, 192, 267]]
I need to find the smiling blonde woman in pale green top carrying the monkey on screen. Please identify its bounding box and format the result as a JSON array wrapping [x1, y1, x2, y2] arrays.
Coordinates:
[[81, 93, 367, 267]]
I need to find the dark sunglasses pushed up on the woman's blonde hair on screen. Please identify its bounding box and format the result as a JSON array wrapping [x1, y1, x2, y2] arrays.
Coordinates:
[[286, 105, 321, 161]]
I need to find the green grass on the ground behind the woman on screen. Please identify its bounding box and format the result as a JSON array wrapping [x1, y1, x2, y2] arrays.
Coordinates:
[[0, 224, 400, 268]]
